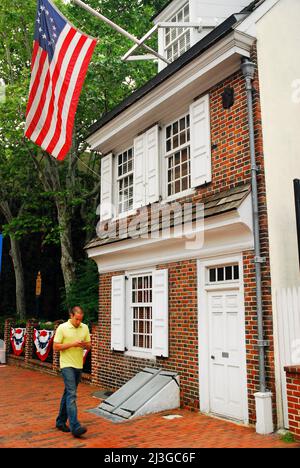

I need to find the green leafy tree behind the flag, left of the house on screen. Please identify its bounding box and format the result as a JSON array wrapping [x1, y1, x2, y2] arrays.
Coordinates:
[[0, 0, 164, 307]]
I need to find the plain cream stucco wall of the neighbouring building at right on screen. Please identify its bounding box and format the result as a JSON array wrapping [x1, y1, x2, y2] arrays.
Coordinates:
[[256, 0, 300, 290]]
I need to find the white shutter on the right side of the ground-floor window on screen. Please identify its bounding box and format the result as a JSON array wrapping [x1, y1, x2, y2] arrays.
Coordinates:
[[152, 270, 169, 357]]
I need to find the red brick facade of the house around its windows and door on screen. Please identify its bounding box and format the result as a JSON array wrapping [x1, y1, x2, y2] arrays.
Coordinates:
[[95, 50, 276, 424]]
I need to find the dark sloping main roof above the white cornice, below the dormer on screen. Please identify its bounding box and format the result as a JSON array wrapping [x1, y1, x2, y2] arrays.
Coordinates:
[[87, 0, 265, 137]]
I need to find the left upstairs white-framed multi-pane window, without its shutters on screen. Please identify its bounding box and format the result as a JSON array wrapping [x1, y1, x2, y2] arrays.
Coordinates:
[[116, 148, 134, 213]]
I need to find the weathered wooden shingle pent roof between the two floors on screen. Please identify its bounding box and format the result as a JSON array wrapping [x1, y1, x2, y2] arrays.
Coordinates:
[[85, 184, 251, 249]]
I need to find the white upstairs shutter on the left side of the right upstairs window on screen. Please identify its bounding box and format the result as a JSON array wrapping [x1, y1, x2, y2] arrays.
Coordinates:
[[145, 125, 159, 205]]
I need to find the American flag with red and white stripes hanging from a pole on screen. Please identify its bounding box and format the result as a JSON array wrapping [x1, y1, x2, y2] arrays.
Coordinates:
[[25, 0, 97, 160]]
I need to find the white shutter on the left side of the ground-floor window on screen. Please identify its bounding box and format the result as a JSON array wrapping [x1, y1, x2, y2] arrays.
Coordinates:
[[111, 275, 126, 351]]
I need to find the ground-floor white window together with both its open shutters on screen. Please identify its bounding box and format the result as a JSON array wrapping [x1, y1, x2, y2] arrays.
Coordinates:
[[111, 268, 169, 359]]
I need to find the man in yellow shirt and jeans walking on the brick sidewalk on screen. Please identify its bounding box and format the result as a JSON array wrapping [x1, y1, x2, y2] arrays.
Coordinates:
[[53, 306, 91, 437]]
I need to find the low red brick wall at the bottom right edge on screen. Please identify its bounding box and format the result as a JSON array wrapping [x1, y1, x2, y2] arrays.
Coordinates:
[[284, 366, 300, 440]]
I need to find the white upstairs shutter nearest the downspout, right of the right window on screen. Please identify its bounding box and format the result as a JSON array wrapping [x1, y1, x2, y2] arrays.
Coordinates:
[[190, 94, 211, 188]]
